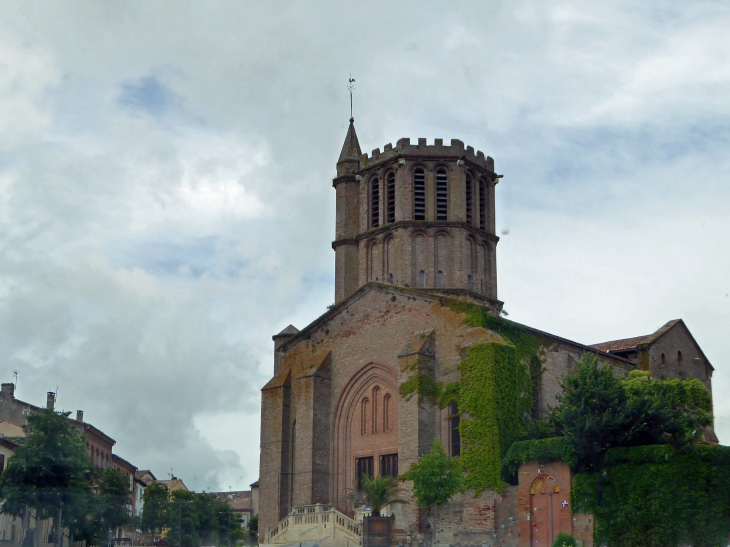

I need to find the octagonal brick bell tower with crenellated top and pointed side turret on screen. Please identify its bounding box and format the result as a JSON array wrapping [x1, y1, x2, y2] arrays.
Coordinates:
[[332, 118, 500, 302]]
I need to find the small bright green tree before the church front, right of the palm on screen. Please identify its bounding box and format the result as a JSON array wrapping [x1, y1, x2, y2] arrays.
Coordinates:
[[400, 439, 463, 507]]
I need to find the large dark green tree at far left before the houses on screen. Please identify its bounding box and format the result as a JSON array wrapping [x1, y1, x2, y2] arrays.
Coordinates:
[[0, 410, 91, 544]]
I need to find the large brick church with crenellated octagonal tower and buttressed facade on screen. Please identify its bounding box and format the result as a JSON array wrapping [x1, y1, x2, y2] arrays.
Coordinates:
[[259, 119, 716, 546]]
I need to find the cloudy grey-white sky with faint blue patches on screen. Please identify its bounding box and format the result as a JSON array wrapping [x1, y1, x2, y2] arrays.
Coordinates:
[[0, 0, 730, 490]]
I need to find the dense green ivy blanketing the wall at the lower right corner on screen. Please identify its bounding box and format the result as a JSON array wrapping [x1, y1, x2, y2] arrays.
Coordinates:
[[572, 445, 730, 547]]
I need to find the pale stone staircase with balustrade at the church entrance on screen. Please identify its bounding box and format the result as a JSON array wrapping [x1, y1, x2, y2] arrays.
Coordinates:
[[260, 503, 362, 547]]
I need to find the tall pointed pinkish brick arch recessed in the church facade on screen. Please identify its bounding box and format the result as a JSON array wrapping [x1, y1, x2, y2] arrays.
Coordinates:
[[331, 361, 398, 515]]
